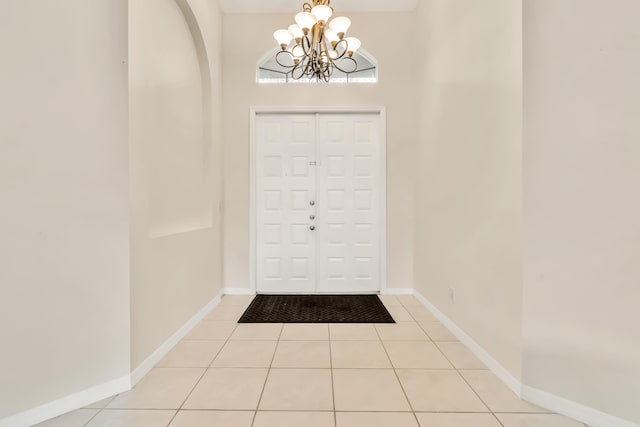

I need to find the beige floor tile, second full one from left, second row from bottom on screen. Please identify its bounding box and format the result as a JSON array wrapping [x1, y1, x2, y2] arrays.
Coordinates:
[[183, 368, 268, 411]]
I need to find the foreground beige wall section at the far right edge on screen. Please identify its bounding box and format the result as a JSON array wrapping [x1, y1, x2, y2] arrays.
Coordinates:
[[523, 0, 640, 423]]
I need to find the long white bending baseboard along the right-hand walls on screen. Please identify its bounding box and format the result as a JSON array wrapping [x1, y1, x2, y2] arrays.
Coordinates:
[[414, 291, 640, 427]]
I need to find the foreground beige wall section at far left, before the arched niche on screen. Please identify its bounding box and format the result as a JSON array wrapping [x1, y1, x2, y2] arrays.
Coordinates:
[[0, 0, 129, 425]]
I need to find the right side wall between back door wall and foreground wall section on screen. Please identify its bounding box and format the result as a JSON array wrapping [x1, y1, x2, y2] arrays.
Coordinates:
[[414, 0, 522, 378]]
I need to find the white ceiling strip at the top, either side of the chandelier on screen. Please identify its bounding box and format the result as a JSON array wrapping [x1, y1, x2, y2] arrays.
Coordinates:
[[221, 0, 418, 13]]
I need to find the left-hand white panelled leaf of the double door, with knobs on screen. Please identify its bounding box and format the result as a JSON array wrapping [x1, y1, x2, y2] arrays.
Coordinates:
[[256, 115, 316, 292]]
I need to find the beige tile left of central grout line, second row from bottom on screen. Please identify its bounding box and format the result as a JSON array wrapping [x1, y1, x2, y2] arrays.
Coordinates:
[[260, 369, 333, 411]]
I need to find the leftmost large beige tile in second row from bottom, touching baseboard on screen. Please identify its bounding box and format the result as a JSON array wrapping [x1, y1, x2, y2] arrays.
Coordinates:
[[107, 368, 205, 409]]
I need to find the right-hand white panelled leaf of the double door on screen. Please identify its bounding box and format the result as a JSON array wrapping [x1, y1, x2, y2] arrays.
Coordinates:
[[316, 114, 380, 292]]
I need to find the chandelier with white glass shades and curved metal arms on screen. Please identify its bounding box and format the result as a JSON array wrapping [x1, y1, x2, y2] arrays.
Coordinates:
[[273, 0, 361, 82]]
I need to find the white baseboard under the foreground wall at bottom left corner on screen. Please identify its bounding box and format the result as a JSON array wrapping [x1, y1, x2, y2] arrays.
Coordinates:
[[0, 375, 131, 427]]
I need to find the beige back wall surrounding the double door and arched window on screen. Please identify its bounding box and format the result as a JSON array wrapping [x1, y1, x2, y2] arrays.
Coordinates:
[[223, 11, 418, 289]]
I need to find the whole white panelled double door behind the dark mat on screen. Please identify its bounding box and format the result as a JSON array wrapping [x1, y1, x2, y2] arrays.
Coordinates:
[[255, 114, 384, 293]]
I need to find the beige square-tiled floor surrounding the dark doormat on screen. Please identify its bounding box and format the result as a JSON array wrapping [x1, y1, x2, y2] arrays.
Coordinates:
[[33, 296, 584, 427]]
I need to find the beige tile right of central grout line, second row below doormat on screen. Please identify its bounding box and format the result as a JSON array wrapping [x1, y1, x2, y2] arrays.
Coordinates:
[[331, 341, 391, 368]]
